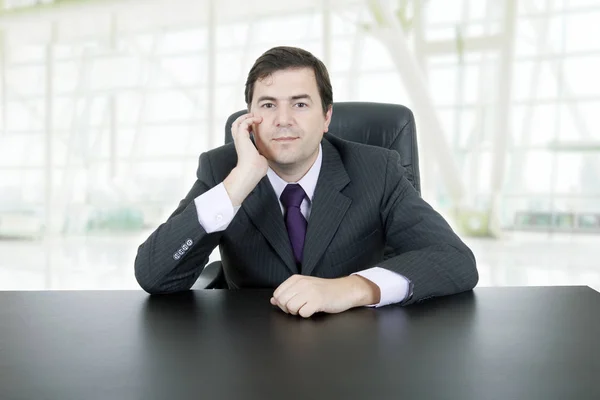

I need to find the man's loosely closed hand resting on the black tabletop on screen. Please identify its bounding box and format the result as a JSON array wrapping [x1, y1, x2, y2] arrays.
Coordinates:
[[271, 275, 380, 318]]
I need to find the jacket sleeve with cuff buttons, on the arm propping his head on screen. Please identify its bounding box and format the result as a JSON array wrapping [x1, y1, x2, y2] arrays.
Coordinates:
[[135, 153, 223, 294]]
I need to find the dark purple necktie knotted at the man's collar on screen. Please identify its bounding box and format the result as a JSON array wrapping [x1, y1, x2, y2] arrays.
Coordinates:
[[280, 183, 307, 265]]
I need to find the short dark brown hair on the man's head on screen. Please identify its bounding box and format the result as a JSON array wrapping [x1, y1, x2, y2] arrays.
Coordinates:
[[245, 46, 333, 114]]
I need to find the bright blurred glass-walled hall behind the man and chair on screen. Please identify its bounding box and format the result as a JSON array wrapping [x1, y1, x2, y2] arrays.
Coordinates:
[[0, 0, 600, 290]]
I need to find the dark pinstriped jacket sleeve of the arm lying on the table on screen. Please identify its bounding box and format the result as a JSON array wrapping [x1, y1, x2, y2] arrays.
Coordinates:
[[379, 152, 479, 305]]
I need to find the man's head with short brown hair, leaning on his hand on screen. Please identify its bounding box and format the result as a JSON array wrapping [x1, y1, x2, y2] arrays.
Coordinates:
[[245, 47, 333, 179]]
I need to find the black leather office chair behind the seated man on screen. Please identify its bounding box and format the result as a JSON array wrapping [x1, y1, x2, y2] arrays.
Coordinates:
[[194, 102, 421, 289]]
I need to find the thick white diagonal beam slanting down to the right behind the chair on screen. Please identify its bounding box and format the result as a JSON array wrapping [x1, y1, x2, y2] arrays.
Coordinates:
[[368, 0, 465, 207]]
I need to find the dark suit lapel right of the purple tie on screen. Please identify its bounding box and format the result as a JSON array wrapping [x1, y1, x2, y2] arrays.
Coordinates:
[[302, 139, 352, 275]]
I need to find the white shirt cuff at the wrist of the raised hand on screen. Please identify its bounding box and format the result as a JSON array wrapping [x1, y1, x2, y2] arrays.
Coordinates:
[[194, 183, 240, 233]]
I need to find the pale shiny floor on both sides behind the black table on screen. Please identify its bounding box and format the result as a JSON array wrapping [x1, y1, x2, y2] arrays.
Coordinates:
[[0, 232, 600, 291]]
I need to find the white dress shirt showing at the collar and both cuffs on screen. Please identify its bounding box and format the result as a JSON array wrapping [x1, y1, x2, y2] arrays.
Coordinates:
[[194, 146, 409, 307]]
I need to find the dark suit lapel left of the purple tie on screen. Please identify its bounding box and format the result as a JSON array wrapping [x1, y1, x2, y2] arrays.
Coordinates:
[[242, 176, 298, 274]]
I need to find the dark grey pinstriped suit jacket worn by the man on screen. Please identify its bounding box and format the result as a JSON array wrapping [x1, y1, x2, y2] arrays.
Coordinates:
[[135, 134, 478, 304]]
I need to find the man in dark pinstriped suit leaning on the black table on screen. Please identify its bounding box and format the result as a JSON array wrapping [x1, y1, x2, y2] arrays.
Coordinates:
[[135, 47, 478, 317]]
